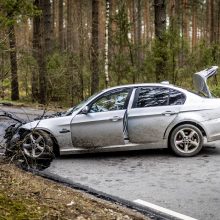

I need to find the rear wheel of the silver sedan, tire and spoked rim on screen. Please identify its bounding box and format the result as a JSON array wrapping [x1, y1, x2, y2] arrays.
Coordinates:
[[170, 124, 204, 157]]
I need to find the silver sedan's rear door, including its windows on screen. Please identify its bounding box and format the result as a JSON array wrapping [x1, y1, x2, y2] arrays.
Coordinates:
[[128, 86, 185, 143]]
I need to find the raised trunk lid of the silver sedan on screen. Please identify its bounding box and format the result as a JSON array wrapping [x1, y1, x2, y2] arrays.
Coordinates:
[[193, 66, 218, 98]]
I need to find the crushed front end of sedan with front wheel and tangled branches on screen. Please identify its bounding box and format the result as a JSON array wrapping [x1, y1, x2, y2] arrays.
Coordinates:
[[1, 112, 55, 170]]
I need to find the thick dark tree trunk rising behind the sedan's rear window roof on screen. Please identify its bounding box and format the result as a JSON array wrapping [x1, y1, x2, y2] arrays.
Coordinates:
[[154, 0, 167, 82]]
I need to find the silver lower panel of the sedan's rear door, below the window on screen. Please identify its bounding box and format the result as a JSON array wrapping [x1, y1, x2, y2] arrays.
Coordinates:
[[128, 106, 179, 143]]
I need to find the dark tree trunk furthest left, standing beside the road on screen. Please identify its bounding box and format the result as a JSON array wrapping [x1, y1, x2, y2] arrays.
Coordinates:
[[8, 24, 19, 101]]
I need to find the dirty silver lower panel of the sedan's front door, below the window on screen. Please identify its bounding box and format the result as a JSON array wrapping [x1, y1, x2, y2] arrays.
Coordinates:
[[71, 110, 125, 148]]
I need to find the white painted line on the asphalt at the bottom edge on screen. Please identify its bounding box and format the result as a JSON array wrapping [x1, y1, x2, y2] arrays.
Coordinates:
[[133, 199, 197, 220]]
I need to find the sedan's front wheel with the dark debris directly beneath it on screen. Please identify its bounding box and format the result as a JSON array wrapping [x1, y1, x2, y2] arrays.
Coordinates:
[[20, 130, 55, 170]]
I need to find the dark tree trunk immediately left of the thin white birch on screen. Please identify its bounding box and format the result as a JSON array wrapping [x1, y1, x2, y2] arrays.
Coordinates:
[[91, 0, 99, 94]]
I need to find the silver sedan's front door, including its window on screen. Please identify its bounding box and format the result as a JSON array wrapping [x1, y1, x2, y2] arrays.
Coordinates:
[[71, 88, 130, 148]]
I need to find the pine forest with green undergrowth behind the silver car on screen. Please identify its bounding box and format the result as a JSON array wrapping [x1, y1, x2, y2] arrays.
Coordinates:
[[0, 0, 220, 106]]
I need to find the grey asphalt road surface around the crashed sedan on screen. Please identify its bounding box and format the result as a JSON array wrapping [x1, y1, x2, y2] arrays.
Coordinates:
[[0, 107, 220, 220]]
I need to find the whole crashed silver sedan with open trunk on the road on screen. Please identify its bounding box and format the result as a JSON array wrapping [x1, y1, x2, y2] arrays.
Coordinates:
[[6, 66, 220, 158]]
